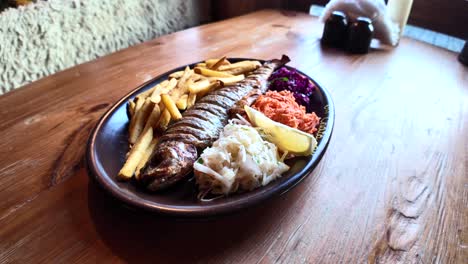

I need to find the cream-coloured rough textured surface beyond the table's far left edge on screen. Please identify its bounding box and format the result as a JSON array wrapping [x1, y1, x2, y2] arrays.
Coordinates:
[[0, 0, 206, 94]]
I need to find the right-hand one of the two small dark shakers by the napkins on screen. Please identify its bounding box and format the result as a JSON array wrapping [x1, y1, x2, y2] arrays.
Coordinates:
[[346, 17, 374, 54]]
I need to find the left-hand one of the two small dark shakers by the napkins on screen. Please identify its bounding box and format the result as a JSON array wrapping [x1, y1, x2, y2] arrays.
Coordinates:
[[321, 11, 348, 48]]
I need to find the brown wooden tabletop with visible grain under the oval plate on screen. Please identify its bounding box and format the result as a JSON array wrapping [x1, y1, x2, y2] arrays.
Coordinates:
[[0, 11, 468, 263]]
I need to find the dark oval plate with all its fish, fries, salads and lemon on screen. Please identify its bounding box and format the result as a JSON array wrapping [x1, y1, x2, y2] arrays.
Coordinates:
[[86, 55, 334, 217]]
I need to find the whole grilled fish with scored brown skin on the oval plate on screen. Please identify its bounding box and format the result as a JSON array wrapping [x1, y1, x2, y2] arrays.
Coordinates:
[[141, 55, 289, 191]]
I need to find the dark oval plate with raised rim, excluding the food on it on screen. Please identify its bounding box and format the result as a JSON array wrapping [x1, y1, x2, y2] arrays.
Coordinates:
[[86, 58, 335, 217]]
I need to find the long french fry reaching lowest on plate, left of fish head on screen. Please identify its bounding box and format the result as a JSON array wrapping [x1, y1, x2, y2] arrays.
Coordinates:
[[118, 128, 153, 181]]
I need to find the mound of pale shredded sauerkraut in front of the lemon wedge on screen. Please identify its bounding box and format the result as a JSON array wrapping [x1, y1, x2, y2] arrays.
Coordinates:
[[193, 122, 289, 196]]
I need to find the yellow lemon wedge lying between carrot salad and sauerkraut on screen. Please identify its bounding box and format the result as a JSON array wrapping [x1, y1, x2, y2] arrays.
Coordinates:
[[244, 105, 317, 156]]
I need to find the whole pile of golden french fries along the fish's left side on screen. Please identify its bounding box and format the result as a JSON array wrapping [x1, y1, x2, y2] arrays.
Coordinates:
[[118, 57, 261, 180]]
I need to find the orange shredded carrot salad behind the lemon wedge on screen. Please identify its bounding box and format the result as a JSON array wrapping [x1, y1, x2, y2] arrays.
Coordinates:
[[252, 90, 320, 134]]
